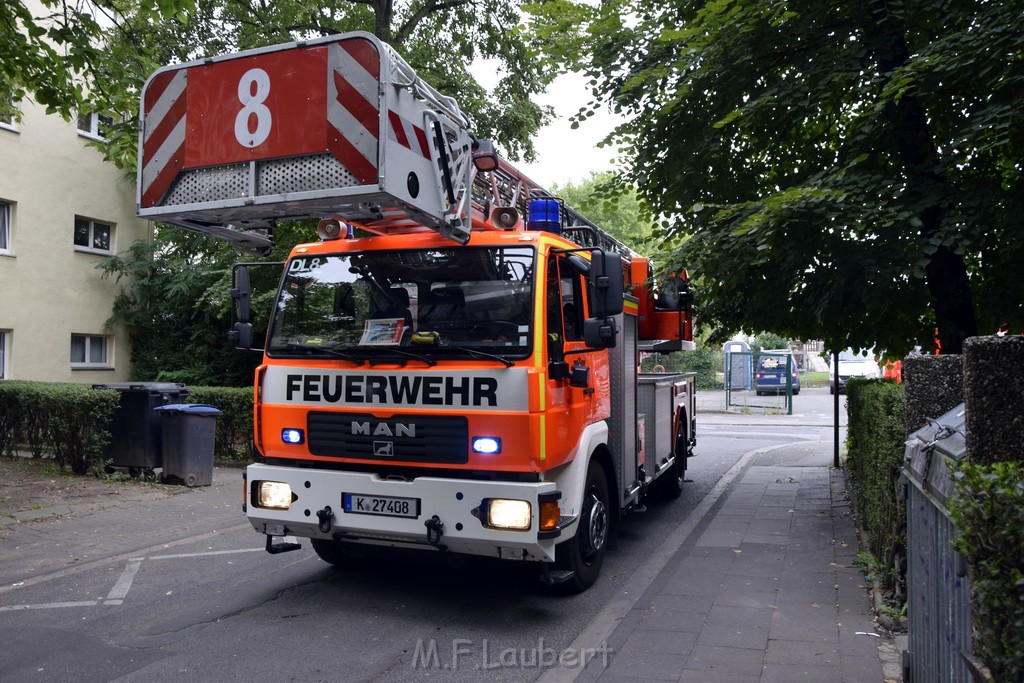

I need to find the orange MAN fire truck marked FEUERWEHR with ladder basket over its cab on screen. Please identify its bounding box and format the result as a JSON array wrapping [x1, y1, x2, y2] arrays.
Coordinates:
[[137, 32, 695, 592]]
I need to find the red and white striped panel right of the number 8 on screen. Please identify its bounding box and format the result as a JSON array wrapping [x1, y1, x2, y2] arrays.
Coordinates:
[[327, 38, 380, 184]]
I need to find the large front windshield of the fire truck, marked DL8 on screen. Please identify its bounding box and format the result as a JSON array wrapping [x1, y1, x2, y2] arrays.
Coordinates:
[[267, 247, 536, 364]]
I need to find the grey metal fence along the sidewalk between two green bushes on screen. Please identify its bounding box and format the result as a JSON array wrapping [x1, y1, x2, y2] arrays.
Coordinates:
[[902, 404, 972, 683]]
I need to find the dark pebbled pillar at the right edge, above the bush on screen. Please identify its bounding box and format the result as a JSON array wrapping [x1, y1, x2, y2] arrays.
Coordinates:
[[964, 336, 1024, 463]]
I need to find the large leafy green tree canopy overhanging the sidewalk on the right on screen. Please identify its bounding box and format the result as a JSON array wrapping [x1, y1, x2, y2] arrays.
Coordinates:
[[583, 0, 1024, 353]]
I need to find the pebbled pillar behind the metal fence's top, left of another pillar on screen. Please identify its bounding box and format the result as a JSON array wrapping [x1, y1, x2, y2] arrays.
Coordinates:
[[903, 354, 964, 435]]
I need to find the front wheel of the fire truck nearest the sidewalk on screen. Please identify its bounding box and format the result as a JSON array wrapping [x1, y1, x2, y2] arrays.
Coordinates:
[[555, 462, 611, 593]]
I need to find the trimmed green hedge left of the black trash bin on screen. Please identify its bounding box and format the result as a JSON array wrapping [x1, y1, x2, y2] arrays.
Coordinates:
[[0, 381, 118, 474]]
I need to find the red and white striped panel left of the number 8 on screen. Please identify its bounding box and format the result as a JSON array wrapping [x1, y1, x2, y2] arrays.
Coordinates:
[[141, 69, 188, 207]]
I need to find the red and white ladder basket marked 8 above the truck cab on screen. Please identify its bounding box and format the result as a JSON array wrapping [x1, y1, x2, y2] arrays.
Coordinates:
[[136, 32, 473, 247]]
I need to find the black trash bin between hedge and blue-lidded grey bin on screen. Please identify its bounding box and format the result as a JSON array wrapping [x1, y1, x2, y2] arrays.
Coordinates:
[[92, 382, 188, 476]]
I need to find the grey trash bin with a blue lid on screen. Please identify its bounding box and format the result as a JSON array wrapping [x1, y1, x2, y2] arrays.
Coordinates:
[[156, 403, 222, 486]]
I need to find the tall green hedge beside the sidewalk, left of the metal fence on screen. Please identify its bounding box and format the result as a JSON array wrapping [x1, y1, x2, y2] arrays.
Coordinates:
[[846, 379, 906, 594]]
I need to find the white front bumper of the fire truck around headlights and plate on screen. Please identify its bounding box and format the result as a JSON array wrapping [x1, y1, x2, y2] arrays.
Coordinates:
[[246, 465, 568, 562]]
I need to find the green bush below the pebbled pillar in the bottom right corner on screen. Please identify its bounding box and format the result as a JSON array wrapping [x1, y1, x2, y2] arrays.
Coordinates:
[[949, 462, 1024, 681]]
